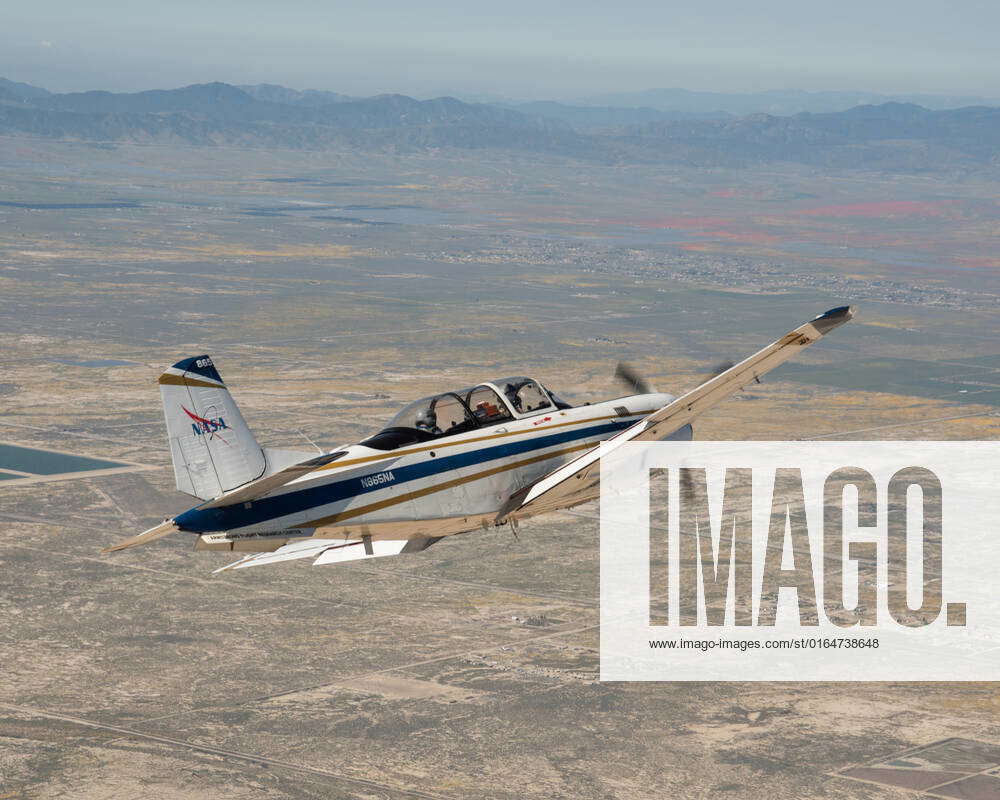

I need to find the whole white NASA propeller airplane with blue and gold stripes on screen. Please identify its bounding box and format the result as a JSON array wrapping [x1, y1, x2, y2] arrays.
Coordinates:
[[102, 306, 855, 572]]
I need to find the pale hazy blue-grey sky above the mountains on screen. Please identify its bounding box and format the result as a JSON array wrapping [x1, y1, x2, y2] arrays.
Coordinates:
[[0, 0, 1000, 99]]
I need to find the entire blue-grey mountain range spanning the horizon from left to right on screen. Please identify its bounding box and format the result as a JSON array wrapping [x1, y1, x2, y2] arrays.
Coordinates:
[[0, 79, 1000, 172]]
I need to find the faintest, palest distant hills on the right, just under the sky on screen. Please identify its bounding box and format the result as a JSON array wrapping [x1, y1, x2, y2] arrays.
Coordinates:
[[575, 89, 1000, 116]]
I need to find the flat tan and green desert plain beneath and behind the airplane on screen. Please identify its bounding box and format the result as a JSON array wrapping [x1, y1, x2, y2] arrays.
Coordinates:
[[0, 138, 1000, 800]]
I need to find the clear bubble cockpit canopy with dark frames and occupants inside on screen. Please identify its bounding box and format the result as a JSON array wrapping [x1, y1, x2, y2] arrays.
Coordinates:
[[362, 377, 570, 450]]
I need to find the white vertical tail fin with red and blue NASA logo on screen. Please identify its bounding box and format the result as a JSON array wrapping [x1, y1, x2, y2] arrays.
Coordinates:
[[159, 356, 265, 500]]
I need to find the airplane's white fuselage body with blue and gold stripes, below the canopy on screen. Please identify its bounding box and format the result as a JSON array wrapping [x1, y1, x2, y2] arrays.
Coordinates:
[[176, 393, 690, 551]]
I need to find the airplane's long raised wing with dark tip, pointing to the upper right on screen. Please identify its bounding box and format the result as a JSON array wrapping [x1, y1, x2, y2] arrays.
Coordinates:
[[496, 306, 855, 523]]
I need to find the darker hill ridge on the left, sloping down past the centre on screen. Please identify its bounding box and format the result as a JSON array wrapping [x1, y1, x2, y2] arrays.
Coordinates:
[[0, 83, 594, 157]]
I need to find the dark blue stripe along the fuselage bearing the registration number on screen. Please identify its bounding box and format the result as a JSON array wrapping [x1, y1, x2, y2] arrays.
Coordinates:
[[174, 419, 635, 533]]
